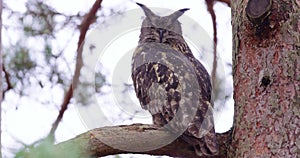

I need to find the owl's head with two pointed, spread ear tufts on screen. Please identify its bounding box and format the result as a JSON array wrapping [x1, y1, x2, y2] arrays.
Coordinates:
[[137, 3, 189, 42]]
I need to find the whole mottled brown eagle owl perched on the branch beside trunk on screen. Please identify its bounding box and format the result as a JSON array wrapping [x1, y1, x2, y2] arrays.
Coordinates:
[[132, 3, 218, 156]]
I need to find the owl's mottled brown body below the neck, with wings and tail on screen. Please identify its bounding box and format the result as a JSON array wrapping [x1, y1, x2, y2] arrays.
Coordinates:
[[132, 44, 218, 155]]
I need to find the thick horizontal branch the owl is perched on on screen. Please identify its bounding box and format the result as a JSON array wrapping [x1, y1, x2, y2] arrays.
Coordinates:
[[53, 124, 231, 158]]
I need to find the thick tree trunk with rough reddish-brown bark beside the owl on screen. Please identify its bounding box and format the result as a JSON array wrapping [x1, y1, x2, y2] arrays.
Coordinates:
[[229, 0, 300, 157]]
